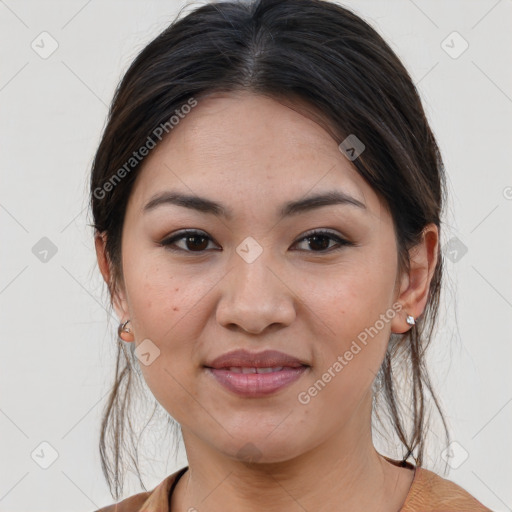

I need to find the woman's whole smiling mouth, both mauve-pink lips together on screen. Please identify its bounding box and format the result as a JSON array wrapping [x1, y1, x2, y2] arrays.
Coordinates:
[[205, 350, 309, 398]]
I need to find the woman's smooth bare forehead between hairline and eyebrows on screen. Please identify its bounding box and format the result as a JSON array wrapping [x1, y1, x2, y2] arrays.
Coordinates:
[[130, 91, 381, 218]]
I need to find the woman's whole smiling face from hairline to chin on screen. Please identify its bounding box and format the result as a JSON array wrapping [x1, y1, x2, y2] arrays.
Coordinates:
[[101, 93, 416, 462]]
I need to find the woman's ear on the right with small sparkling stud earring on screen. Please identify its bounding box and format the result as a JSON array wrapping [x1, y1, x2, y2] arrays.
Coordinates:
[[391, 223, 439, 334]]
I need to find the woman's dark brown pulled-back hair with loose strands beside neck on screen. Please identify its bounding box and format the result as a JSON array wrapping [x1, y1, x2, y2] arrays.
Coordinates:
[[90, 0, 449, 500]]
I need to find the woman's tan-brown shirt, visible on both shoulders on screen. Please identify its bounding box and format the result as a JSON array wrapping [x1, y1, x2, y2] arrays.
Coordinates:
[[94, 466, 492, 512]]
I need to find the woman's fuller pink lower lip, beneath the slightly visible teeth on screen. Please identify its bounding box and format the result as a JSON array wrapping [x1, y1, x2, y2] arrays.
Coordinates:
[[206, 366, 308, 398]]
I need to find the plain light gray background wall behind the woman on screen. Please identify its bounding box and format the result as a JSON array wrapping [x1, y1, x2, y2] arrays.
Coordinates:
[[0, 0, 512, 512]]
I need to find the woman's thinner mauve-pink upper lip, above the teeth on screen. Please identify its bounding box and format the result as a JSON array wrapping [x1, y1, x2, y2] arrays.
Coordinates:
[[205, 349, 309, 368]]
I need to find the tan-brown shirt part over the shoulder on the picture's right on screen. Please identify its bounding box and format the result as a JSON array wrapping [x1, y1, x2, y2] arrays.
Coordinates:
[[400, 467, 492, 512]]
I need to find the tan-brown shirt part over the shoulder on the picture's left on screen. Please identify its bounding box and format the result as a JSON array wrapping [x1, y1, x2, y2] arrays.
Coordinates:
[[94, 466, 188, 512]]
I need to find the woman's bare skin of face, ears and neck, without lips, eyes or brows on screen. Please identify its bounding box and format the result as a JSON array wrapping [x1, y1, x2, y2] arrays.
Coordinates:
[[96, 92, 438, 512]]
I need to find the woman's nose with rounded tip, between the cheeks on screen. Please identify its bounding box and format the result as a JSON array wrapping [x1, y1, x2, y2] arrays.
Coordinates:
[[216, 245, 296, 334]]
